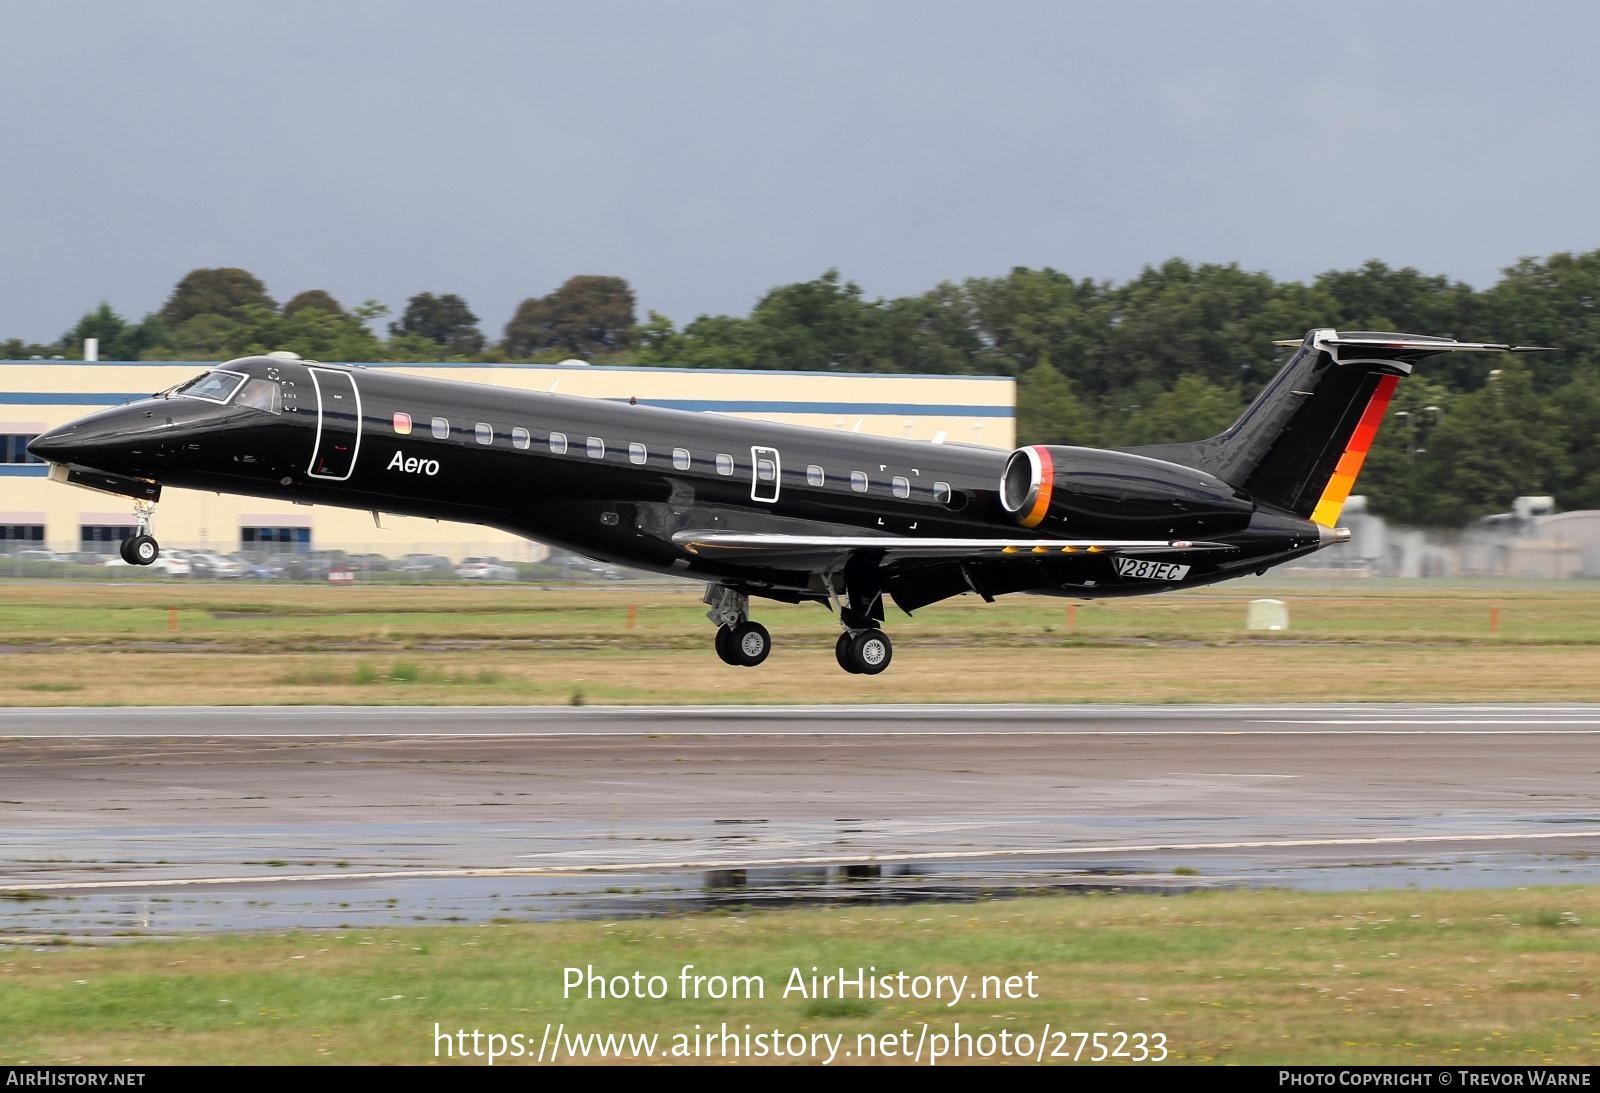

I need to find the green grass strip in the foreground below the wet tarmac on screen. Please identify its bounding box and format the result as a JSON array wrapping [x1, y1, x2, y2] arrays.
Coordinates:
[[0, 888, 1600, 1064]]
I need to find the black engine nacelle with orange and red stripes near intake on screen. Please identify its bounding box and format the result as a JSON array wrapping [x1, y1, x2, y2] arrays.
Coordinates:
[[1000, 445, 1256, 539]]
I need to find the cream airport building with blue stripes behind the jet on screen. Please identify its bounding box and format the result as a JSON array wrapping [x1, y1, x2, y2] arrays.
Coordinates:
[[0, 360, 1016, 562]]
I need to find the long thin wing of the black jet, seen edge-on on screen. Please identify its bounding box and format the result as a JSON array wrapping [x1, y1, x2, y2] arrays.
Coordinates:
[[672, 531, 1234, 560]]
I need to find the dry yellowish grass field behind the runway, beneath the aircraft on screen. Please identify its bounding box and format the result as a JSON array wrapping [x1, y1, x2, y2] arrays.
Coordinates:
[[0, 581, 1600, 706]]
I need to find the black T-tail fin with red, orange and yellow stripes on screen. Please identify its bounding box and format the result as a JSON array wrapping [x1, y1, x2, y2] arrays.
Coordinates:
[[1133, 330, 1555, 528]]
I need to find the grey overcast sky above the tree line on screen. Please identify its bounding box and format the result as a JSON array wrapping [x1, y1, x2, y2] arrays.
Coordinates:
[[0, 0, 1600, 341]]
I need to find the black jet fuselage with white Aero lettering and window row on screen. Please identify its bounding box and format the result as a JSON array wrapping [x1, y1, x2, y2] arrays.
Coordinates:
[[34, 357, 1322, 607]]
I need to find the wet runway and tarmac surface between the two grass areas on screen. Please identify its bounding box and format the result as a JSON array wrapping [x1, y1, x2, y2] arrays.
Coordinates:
[[0, 706, 1600, 933]]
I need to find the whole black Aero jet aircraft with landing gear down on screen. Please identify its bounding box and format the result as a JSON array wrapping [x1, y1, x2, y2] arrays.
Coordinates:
[[29, 330, 1528, 674]]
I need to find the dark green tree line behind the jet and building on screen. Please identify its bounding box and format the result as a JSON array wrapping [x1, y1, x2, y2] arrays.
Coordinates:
[[0, 251, 1600, 526]]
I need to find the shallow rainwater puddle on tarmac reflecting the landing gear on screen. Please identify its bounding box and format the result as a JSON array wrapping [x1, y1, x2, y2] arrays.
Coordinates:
[[0, 853, 1600, 939]]
